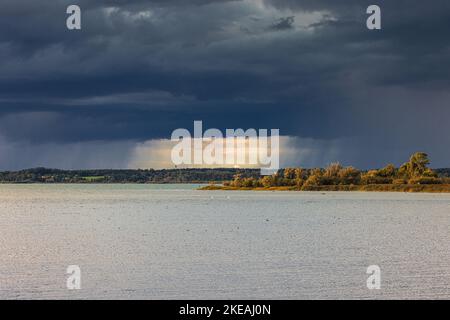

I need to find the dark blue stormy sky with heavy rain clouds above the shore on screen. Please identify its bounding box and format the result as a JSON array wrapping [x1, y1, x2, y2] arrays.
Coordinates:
[[0, 0, 450, 170]]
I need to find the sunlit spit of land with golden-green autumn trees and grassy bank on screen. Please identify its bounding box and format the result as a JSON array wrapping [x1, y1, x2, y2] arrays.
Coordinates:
[[200, 152, 450, 193]]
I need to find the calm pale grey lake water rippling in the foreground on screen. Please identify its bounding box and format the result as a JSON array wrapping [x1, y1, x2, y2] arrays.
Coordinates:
[[0, 185, 450, 299]]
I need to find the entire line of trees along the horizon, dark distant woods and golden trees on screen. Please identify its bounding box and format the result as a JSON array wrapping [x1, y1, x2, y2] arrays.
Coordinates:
[[0, 152, 450, 185]]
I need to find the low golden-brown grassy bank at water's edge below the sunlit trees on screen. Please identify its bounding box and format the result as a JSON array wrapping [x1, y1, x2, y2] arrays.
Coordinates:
[[199, 184, 450, 193]]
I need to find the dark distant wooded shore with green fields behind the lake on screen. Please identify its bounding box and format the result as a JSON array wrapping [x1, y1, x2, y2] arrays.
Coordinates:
[[0, 168, 260, 183]]
